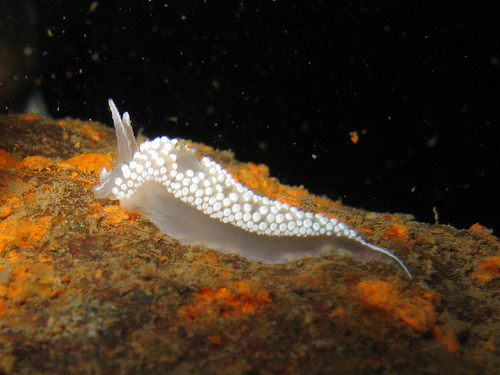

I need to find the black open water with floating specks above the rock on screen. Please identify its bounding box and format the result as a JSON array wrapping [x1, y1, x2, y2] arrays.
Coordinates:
[[1, 0, 500, 234]]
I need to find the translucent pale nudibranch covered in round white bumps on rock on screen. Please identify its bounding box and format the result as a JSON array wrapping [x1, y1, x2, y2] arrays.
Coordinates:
[[94, 99, 412, 278]]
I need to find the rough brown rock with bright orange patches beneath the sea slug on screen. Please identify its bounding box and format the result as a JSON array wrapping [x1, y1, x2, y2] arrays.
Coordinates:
[[0, 115, 500, 374]]
